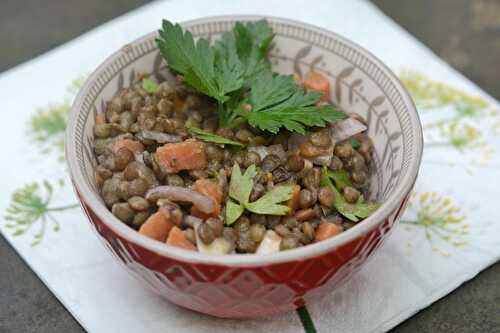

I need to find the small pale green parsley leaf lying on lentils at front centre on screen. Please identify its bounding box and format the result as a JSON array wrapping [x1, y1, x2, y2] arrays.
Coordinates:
[[226, 163, 293, 225]]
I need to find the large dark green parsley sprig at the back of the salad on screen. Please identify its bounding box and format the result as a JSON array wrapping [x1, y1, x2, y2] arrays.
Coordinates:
[[157, 20, 346, 133]]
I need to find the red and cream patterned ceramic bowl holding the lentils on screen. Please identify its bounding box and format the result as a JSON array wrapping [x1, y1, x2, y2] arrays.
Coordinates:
[[66, 16, 423, 318]]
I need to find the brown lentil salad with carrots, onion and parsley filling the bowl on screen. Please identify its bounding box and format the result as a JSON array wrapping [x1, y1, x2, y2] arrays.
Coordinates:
[[94, 21, 378, 254]]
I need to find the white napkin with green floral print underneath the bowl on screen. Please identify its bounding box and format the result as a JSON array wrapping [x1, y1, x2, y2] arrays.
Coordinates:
[[0, 0, 500, 333]]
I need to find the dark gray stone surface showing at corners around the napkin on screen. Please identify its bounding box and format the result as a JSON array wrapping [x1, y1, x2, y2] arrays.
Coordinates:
[[0, 0, 500, 333]]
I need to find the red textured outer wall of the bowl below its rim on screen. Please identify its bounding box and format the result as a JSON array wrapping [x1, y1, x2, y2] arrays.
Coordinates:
[[81, 188, 407, 318]]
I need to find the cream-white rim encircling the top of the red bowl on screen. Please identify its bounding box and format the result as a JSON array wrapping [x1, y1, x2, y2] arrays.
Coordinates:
[[66, 15, 423, 267]]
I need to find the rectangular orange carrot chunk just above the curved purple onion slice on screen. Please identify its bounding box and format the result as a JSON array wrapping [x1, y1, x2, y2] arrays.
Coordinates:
[[156, 141, 207, 173]]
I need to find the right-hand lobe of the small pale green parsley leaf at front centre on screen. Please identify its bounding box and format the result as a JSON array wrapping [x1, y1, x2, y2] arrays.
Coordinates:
[[246, 185, 293, 215]]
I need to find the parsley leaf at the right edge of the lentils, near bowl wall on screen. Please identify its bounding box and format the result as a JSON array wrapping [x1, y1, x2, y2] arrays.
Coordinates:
[[321, 168, 380, 222]]
